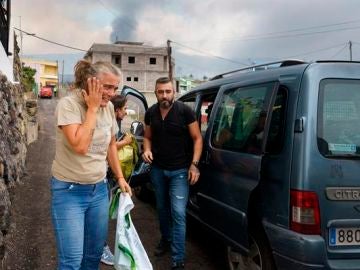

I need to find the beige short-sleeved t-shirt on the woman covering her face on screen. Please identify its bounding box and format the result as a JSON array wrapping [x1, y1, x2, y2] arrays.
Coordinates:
[[52, 90, 118, 184]]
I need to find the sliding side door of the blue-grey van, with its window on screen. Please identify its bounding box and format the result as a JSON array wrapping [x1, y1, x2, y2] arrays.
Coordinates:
[[197, 82, 279, 249]]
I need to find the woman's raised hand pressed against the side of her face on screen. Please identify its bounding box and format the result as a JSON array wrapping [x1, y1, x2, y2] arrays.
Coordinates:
[[81, 77, 103, 112]]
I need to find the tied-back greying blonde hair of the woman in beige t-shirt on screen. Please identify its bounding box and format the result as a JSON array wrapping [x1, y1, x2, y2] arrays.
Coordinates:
[[74, 59, 121, 89]]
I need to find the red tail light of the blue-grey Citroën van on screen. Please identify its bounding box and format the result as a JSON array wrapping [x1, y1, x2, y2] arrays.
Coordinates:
[[290, 190, 321, 235]]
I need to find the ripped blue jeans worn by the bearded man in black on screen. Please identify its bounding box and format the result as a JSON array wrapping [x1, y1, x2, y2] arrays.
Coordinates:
[[150, 166, 189, 262]]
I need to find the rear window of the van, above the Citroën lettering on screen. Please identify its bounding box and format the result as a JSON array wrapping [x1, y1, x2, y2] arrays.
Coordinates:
[[318, 79, 360, 158]]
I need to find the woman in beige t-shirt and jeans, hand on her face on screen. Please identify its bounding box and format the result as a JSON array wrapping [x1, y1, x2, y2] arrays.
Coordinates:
[[51, 60, 131, 270]]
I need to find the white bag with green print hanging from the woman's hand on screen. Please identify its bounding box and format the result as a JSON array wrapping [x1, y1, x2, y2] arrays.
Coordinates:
[[113, 193, 153, 270]]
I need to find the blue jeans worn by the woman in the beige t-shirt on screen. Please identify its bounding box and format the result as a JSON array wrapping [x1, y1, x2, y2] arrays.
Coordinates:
[[51, 177, 109, 270]]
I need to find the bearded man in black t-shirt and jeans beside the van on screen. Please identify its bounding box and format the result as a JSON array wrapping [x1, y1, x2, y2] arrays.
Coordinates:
[[143, 78, 202, 269]]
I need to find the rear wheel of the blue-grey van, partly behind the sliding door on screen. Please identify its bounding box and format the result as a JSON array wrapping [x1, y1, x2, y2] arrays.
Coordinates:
[[227, 231, 276, 270]]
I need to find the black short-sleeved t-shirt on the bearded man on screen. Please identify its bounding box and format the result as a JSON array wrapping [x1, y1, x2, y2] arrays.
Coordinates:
[[145, 101, 196, 170]]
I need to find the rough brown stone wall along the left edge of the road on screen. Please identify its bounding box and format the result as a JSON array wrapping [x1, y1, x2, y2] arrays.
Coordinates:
[[0, 72, 26, 261]]
